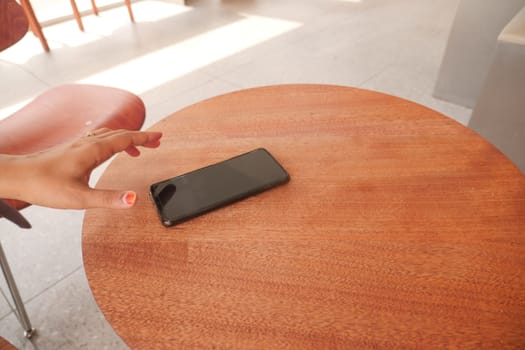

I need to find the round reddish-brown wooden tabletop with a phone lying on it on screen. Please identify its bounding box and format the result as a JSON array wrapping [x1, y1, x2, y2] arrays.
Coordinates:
[[82, 85, 525, 349]]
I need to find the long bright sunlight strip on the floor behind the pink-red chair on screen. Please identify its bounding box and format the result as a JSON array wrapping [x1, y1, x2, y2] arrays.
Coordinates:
[[75, 15, 301, 94]]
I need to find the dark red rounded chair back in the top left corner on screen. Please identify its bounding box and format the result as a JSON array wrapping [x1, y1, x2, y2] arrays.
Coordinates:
[[0, 0, 29, 51]]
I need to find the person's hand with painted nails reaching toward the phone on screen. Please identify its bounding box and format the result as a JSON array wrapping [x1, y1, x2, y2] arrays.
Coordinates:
[[0, 129, 162, 209]]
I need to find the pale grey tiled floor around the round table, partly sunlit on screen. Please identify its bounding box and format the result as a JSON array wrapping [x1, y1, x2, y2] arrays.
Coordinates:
[[0, 0, 470, 350]]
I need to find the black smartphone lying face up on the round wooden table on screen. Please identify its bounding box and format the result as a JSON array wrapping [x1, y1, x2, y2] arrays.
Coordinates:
[[150, 148, 290, 226]]
